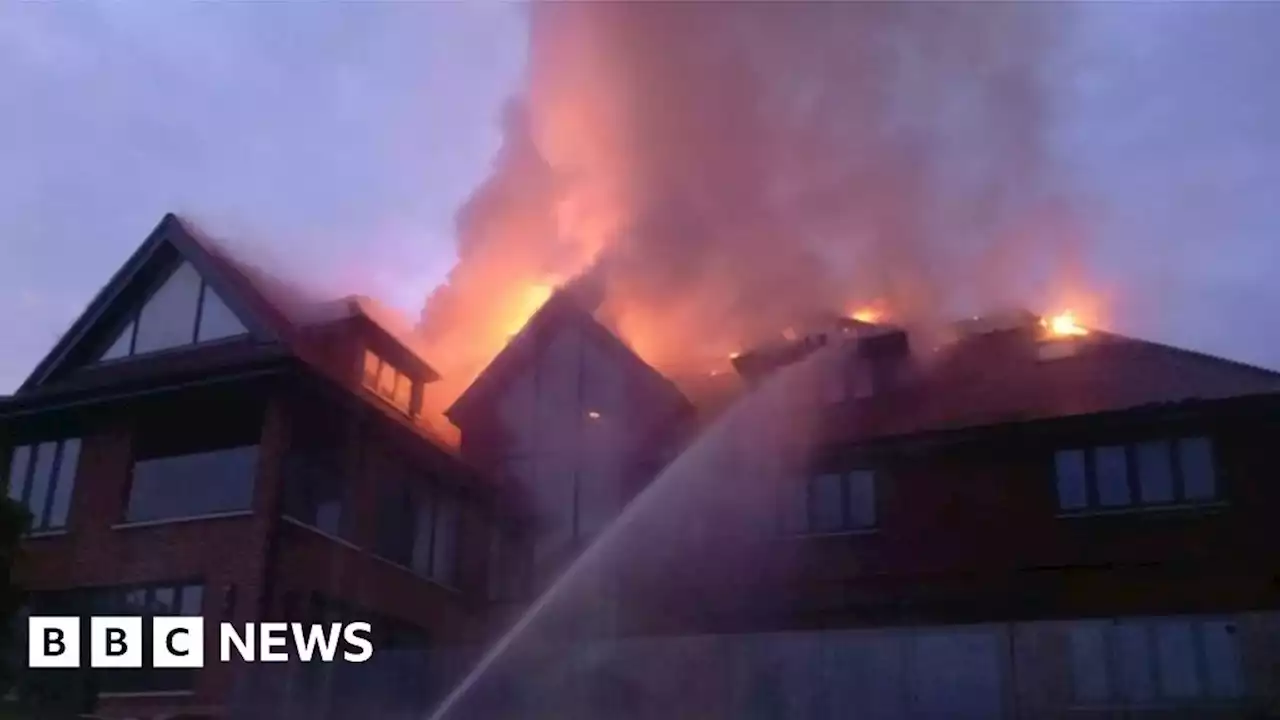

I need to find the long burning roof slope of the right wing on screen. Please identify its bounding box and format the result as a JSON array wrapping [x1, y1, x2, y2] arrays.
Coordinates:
[[829, 319, 1280, 442]]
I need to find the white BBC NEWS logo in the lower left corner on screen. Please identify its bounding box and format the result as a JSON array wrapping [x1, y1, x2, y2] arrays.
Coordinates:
[[27, 616, 374, 667]]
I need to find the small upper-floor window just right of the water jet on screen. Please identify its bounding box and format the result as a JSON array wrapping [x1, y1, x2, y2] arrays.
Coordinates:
[[786, 470, 877, 534]]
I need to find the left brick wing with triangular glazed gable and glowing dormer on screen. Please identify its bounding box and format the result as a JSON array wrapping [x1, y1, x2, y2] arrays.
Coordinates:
[[0, 215, 494, 717]]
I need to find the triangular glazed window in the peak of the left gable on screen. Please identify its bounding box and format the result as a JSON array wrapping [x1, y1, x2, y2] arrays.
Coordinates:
[[100, 263, 248, 360]]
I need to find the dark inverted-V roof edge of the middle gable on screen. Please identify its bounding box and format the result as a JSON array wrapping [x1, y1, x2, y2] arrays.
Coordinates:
[[444, 290, 694, 425]]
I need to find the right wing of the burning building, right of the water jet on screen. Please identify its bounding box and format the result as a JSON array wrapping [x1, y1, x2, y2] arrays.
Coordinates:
[[409, 304, 1280, 719]]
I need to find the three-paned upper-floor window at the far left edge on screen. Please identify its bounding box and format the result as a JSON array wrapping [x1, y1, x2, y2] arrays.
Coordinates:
[[9, 438, 81, 530]]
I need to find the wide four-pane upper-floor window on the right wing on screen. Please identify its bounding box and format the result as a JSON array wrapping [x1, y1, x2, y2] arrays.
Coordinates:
[[1053, 437, 1219, 511]]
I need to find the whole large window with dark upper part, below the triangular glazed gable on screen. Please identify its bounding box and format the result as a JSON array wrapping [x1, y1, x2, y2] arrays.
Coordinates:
[[124, 409, 262, 523]]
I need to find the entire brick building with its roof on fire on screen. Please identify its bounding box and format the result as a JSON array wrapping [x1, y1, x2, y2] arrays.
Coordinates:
[[12, 212, 1280, 720]]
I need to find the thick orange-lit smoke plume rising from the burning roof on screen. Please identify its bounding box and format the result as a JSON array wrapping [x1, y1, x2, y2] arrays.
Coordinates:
[[421, 3, 1078, 404]]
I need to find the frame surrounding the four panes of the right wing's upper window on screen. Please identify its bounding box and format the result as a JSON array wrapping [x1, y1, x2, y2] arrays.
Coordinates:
[[1048, 433, 1226, 516]]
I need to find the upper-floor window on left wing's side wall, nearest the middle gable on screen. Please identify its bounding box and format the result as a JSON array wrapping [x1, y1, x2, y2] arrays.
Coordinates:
[[376, 465, 461, 585]]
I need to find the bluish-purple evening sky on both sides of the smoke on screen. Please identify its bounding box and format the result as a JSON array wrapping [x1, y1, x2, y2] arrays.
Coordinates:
[[0, 0, 1280, 393]]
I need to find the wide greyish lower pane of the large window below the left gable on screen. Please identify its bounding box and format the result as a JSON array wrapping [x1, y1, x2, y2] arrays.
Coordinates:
[[125, 445, 257, 521]]
